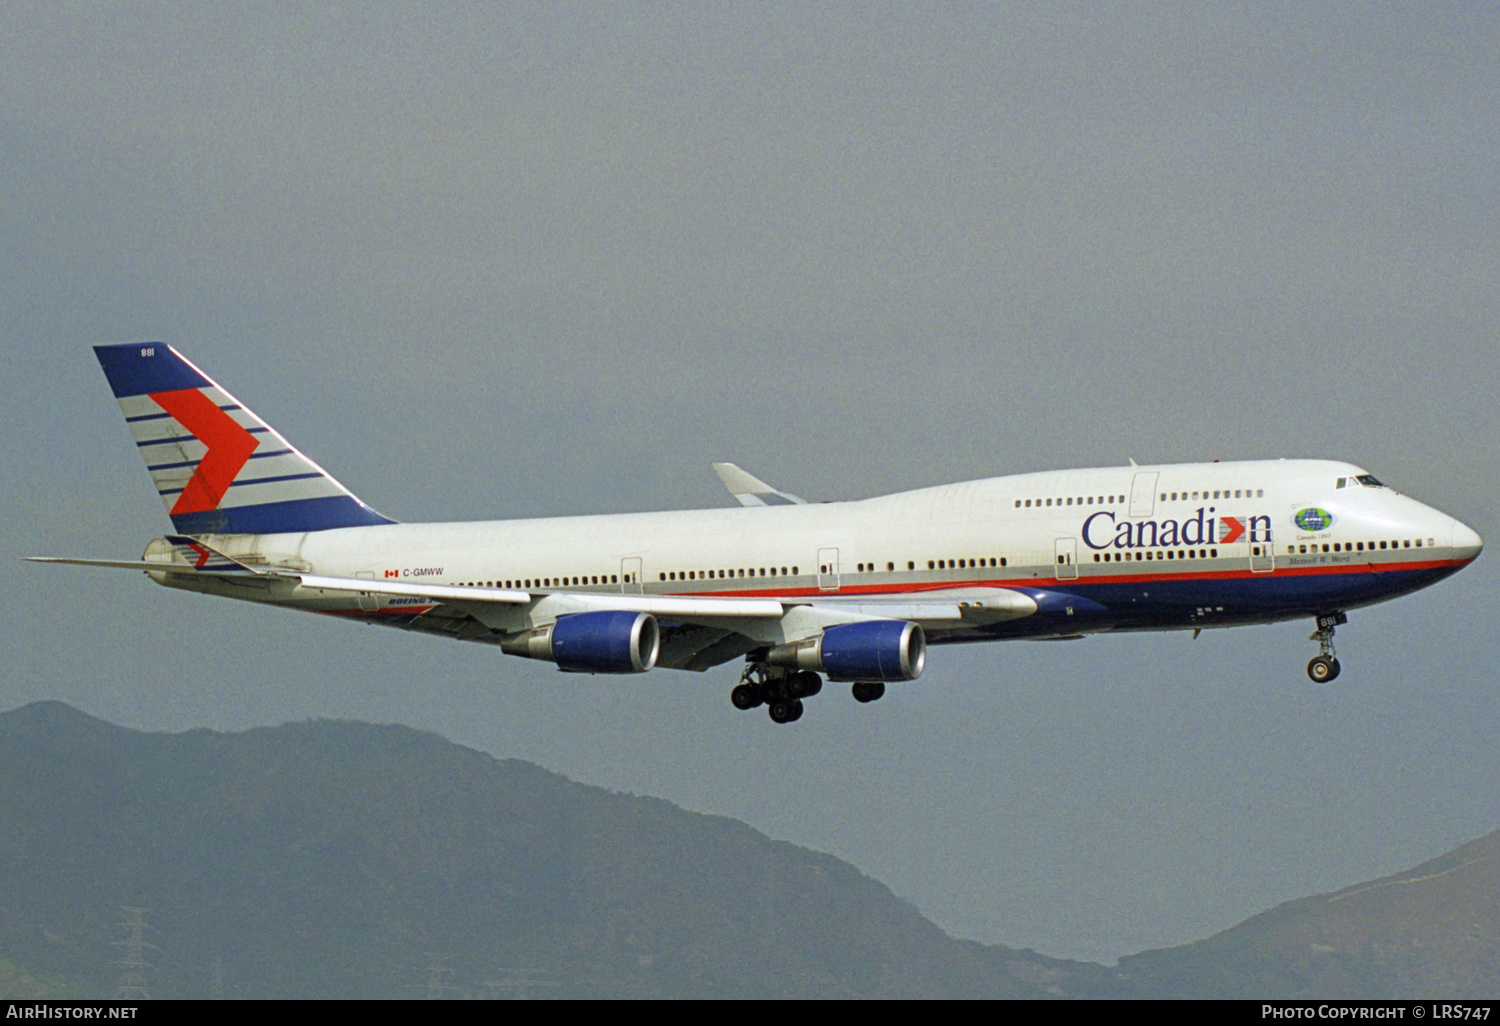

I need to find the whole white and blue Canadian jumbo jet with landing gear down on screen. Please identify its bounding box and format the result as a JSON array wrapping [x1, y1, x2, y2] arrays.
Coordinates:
[[32, 342, 1484, 723]]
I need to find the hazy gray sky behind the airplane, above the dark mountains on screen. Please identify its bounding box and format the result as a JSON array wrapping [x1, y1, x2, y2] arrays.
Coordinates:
[[0, 2, 1500, 960]]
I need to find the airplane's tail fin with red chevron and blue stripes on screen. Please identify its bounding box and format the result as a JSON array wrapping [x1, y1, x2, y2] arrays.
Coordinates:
[[95, 342, 392, 536]]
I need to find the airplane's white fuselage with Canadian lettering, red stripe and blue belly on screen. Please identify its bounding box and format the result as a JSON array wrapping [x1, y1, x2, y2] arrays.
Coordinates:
[[165, 461, 1481, 654]]
